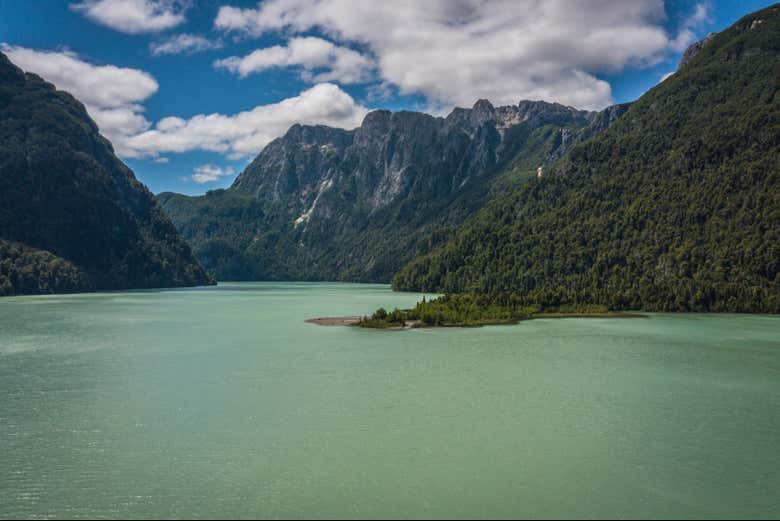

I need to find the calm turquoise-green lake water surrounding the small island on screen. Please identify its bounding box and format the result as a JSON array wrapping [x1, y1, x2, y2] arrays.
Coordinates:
[[0, 283, 780, 518]]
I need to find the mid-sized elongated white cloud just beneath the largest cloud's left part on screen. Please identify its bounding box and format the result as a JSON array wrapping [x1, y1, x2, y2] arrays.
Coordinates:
[[214, 36, 374, 84]]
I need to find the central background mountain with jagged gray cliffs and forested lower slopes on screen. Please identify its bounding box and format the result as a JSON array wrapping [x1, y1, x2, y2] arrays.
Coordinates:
[[158, 100, 627, 282]]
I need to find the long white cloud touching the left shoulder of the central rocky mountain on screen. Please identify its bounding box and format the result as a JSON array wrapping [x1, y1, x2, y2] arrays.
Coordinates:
[[124, 83, 368, 159]]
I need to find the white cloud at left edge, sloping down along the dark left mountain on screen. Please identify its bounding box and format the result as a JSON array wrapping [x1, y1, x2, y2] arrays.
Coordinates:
[[2, 44, 159, 153]]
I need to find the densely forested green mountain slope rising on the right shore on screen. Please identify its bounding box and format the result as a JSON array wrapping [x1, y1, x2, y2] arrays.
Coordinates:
[[394, 4, 780, 313]]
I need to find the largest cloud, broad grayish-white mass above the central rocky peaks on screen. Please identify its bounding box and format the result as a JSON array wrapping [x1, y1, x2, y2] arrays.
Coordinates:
[[215, 0, 704, 108]]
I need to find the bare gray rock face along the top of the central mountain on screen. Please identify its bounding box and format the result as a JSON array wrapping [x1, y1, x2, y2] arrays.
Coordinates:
[[232, 100, 627, 218]]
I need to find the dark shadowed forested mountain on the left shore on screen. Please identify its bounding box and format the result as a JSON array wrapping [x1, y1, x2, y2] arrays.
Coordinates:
[[0, 53, 210, 295]]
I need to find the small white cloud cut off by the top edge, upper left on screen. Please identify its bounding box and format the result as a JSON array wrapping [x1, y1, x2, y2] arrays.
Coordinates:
[[70, 0, 190, 34]]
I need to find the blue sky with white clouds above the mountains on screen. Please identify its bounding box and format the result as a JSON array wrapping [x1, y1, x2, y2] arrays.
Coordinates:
[[0, 0, 773, 195]]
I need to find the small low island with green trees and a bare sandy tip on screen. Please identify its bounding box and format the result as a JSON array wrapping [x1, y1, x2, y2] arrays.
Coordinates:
[[307, 293, 644, 330]]
